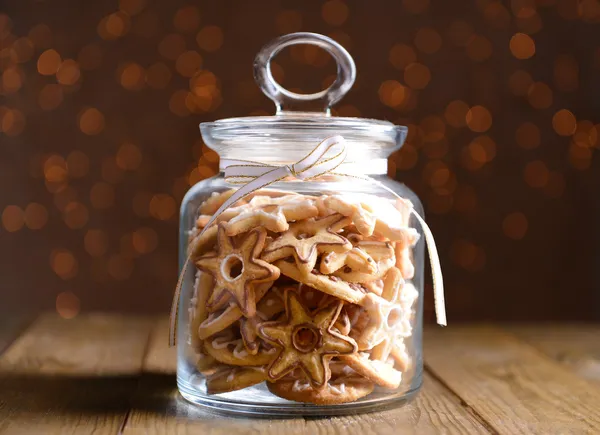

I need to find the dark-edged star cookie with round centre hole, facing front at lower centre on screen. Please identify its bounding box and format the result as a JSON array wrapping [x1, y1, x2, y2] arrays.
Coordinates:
[[258, 290, 357, 388]]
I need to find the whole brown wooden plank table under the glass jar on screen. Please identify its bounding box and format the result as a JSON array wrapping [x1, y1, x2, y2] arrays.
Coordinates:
[[0, 314, 600, 435]]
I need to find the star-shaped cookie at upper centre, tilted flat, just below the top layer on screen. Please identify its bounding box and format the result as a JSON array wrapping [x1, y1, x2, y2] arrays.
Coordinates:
[[262, 214, 352, 274]]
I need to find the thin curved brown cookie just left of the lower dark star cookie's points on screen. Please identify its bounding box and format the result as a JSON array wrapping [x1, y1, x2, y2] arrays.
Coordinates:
[[204, 336, 276, 366]]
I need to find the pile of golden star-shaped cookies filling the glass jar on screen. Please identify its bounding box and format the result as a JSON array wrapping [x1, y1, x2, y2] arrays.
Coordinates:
[[189, 189, 419, 404]]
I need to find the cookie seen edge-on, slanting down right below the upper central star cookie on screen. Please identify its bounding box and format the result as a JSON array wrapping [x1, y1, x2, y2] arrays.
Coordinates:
[[274, 260, 365, 305]]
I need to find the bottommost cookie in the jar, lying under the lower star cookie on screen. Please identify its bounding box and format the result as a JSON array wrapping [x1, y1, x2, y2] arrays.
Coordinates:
[[267, 376, 374, 405]]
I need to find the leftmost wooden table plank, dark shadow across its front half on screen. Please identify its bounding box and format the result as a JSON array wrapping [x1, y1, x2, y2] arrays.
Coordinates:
[[0, 315, 151, 435]]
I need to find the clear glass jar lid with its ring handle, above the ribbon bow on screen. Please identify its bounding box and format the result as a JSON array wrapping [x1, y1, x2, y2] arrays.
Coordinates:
[[200, 32, 407, 169]]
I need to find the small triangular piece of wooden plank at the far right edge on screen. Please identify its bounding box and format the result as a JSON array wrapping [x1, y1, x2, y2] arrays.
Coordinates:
[[503, 324, 600, 383]]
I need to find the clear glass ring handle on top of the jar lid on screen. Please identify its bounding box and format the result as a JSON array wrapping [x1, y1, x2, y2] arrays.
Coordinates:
[[254, 32, 356, 115]]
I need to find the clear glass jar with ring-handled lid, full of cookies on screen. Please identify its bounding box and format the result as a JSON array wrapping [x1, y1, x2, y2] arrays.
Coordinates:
[[177, 33, 424, 415]]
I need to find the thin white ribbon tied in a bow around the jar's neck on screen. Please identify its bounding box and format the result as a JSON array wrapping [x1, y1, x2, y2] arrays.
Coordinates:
[[169, 136, 446, 346]]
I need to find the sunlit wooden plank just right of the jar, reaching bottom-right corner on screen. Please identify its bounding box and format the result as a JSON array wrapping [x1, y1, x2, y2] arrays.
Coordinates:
[[424, 326, 600, 434]]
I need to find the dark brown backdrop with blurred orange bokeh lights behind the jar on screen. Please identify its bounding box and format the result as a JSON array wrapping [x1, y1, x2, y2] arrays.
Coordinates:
[[0, 0, 600, 321]]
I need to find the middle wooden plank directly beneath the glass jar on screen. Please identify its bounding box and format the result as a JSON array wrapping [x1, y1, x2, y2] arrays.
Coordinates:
[[124, 319, 489, 435]]
